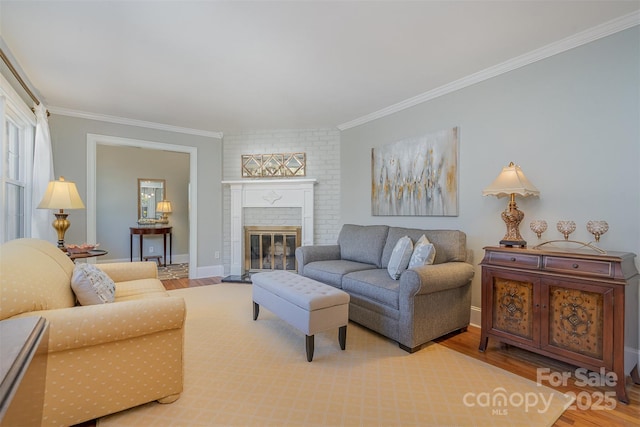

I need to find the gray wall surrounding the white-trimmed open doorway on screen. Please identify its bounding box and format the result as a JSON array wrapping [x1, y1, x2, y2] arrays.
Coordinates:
[[49, 114, 222, 268]]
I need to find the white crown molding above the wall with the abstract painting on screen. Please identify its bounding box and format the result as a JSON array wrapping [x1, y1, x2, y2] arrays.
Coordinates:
[[337, 11, 640, 131]]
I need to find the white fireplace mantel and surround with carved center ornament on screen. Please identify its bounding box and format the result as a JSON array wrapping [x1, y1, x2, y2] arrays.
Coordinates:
[[222, 178, 316, 276]]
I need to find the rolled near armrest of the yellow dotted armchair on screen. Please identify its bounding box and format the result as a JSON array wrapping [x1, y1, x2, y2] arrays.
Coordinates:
[[16, 297, 186, 353]]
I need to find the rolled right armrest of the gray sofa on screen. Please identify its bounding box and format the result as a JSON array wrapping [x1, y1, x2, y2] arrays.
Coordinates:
[[400, 262, 475, 295]]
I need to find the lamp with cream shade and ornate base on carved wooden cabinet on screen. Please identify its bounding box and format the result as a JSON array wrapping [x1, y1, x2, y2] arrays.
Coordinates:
[[482, 162, 540, 247]]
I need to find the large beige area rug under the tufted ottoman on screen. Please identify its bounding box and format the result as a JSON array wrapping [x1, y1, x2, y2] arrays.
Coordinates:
[[98, 283, 571, 427]]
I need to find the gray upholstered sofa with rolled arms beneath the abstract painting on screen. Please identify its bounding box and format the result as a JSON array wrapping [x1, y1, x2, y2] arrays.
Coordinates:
[[296, 224, 474, 353]]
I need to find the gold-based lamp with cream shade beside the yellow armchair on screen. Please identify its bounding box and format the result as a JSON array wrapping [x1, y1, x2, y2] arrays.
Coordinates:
[[38, 176, 84, 252]]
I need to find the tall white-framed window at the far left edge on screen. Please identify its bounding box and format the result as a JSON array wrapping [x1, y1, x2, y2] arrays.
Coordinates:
[[0, 76, 35, 242]]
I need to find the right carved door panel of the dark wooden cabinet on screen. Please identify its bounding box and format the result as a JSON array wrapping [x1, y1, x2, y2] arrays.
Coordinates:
[[542, 279, 613, 368]]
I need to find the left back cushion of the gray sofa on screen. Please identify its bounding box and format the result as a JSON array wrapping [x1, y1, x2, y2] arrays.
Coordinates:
[[338, 224, 388, 269]]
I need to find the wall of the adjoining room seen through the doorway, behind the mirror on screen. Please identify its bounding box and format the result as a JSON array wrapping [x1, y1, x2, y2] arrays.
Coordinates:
[[96, 144, 189, 263]]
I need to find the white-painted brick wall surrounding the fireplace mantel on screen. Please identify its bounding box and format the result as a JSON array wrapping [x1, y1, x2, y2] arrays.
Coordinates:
[[223, 129, 340, 274]]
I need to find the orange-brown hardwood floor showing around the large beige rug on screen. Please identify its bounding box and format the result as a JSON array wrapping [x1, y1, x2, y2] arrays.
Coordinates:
[[72, 277, 640, 427]]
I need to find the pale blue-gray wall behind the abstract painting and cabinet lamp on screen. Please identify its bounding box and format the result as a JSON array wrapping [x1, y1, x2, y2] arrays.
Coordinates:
[[340, 27, 640, 318]]
